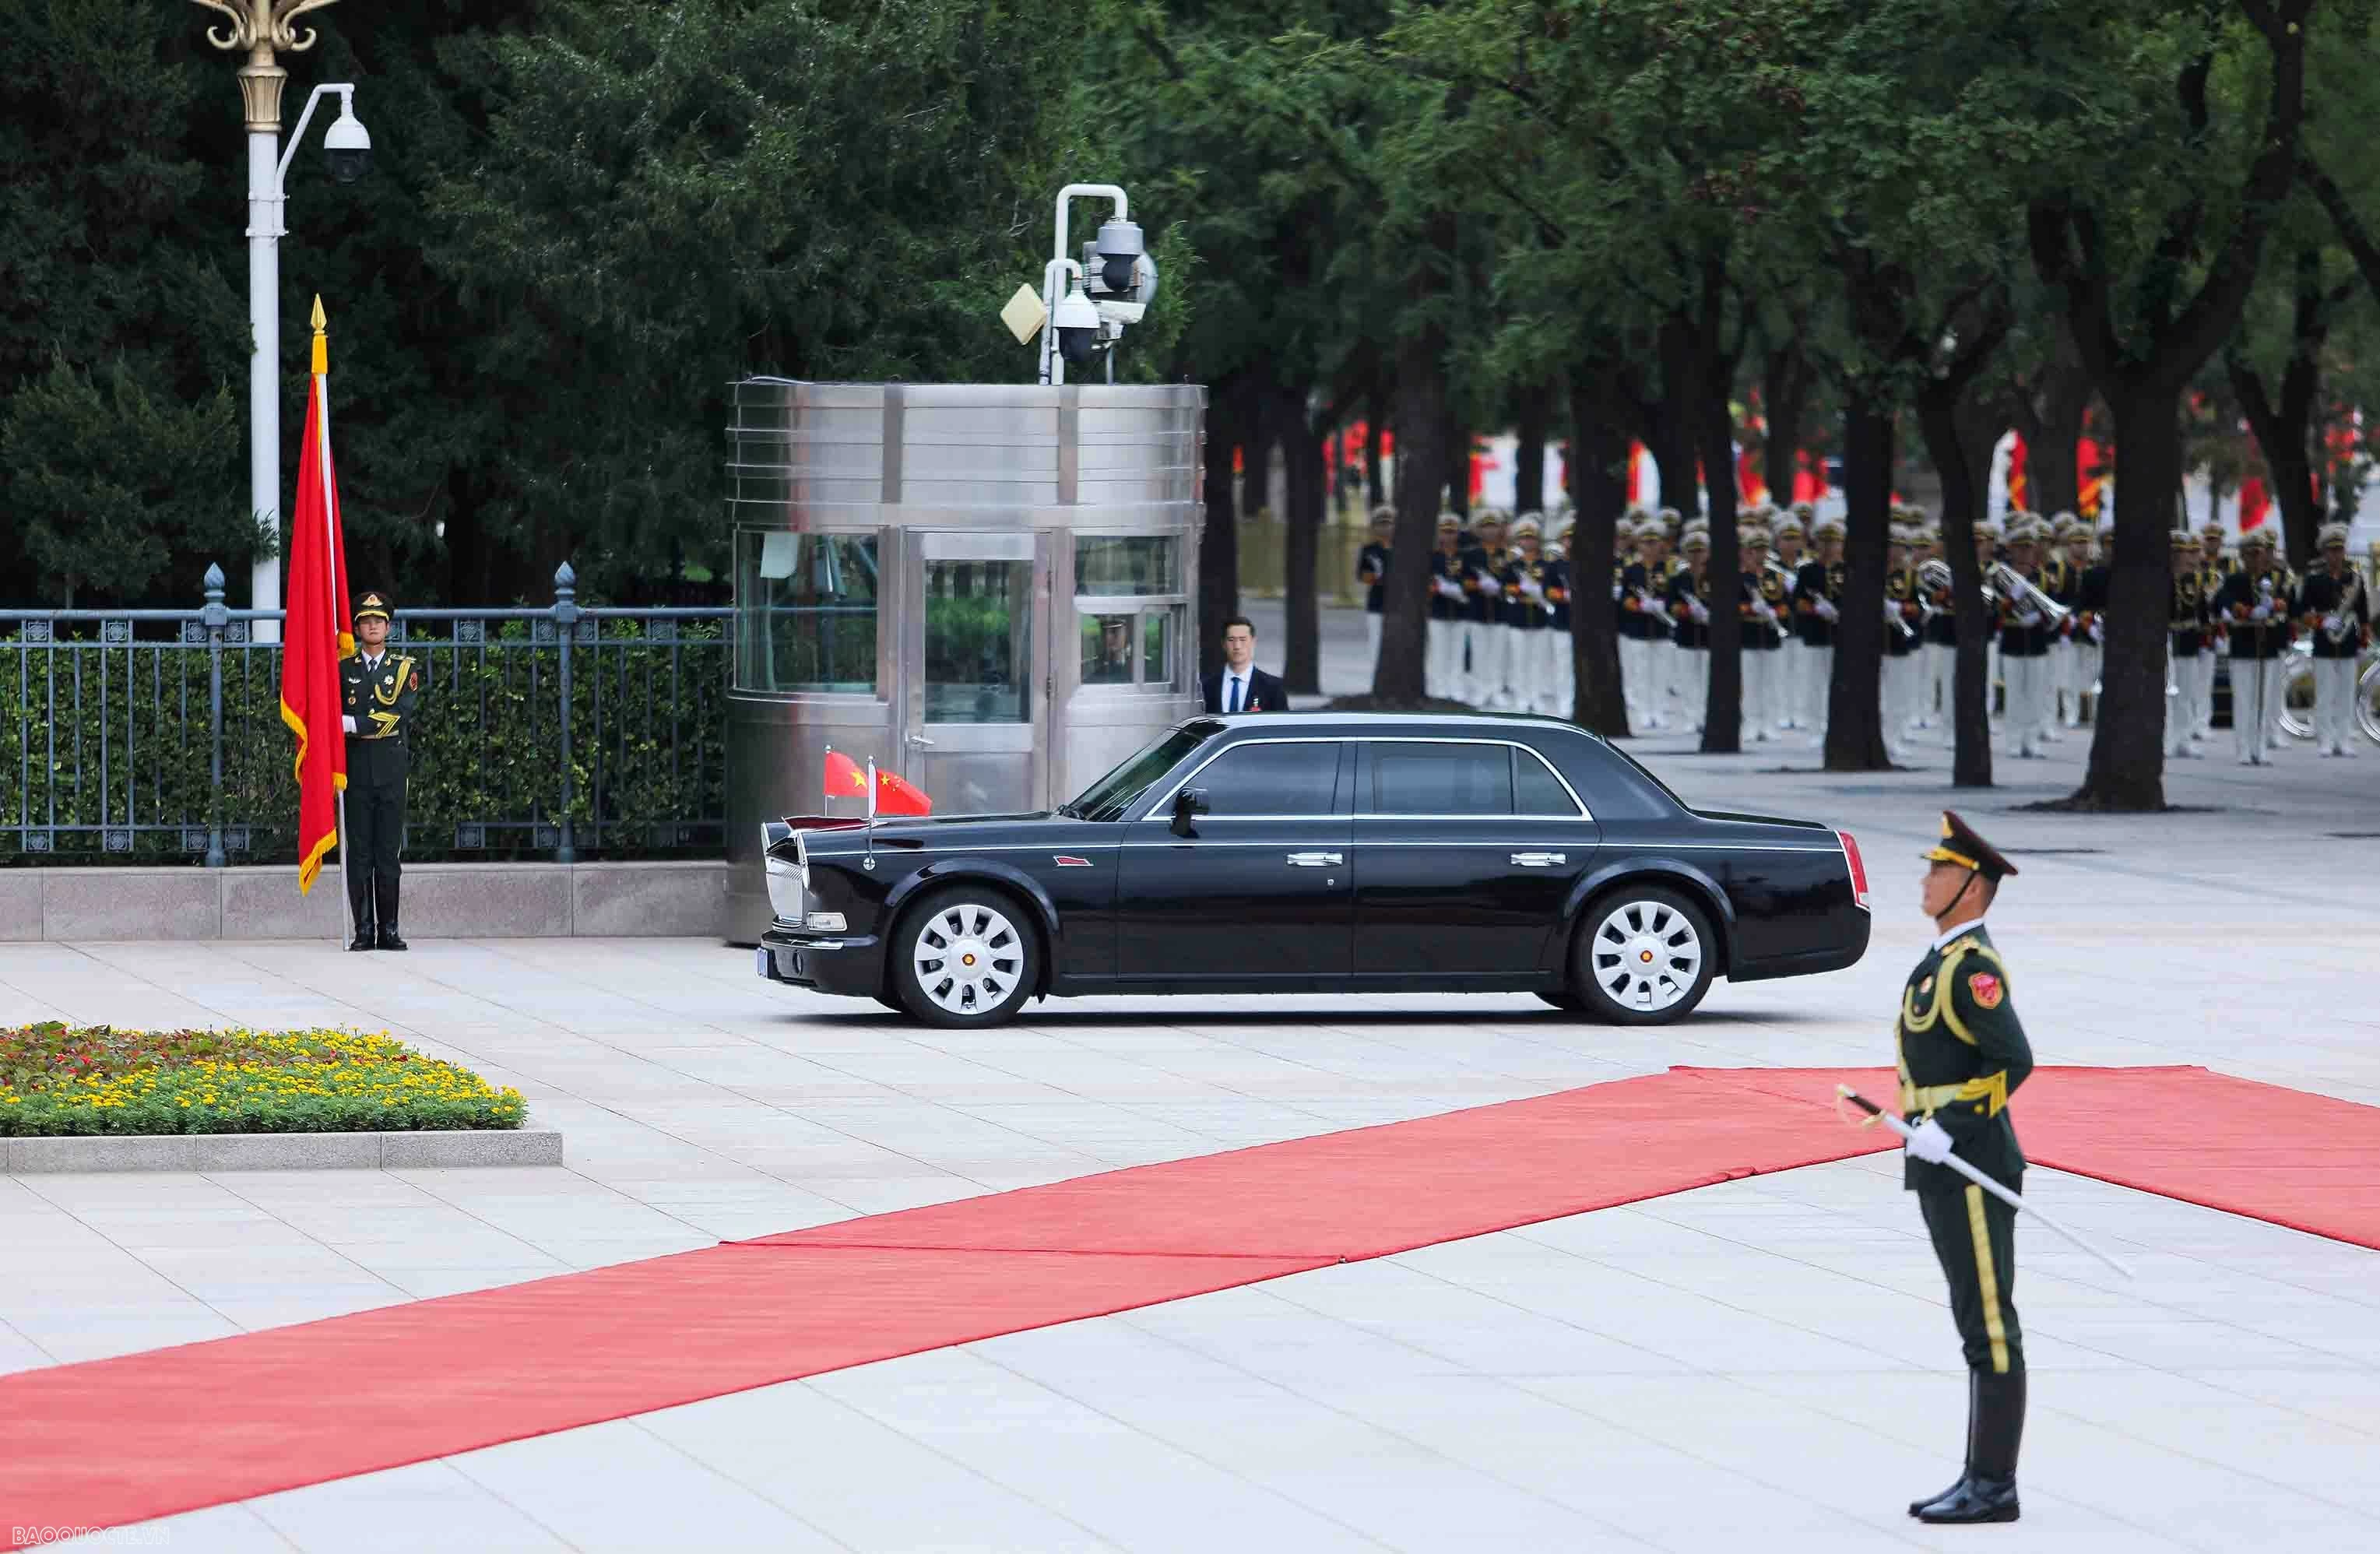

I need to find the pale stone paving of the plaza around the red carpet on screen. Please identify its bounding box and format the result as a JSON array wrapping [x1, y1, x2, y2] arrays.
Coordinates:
[[0, 614, 2380, 1554]]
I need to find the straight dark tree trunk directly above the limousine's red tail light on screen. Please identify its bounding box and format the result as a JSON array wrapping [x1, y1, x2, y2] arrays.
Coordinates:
[[1826, 378, 1892, 771]]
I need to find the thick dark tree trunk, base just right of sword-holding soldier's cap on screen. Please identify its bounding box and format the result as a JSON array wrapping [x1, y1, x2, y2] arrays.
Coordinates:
[[2065, 383, 2182, 811]]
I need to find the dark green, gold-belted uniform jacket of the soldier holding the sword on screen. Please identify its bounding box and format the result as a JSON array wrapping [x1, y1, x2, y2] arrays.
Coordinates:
[[1892, 923, 2033, 1187]]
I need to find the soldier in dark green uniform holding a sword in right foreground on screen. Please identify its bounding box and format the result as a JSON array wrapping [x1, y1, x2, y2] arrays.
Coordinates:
[[1892, 811, 2033, 1523]]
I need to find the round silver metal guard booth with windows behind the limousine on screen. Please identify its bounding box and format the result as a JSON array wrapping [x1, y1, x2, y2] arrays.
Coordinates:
[[726, 378, 1207, 942]]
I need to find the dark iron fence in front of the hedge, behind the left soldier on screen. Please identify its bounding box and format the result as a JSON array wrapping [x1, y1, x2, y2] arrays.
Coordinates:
[[0, 564, 728, 869]]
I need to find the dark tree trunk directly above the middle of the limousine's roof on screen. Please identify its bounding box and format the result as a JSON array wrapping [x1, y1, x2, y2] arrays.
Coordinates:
[[1371, 255, 1454, 707]]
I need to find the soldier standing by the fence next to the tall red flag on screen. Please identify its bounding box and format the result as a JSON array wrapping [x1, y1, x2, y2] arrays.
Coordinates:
[[338, 592, 421, 950]]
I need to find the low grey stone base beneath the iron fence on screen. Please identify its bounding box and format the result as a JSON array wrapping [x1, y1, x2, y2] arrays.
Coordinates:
[[0, 862, 728, 940]]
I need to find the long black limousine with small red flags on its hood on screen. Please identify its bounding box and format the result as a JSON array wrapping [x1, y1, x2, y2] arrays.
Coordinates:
[[757, 714, 1868, 1025]]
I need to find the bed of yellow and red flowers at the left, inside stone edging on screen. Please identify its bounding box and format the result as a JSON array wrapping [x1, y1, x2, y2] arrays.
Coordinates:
[[0, 1021, 529, 1137]]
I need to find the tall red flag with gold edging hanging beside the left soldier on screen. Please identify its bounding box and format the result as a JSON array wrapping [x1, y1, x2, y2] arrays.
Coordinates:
[[281, 297, 354, 895]]
